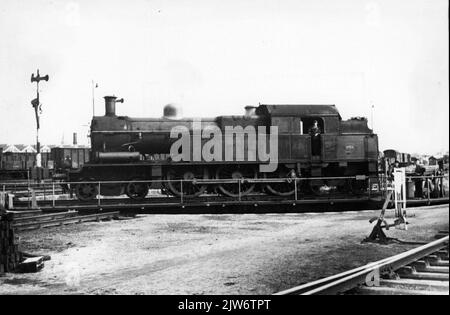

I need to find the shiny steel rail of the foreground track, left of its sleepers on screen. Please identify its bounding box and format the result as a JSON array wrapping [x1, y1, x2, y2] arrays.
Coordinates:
[[275, 235, 449, 295]]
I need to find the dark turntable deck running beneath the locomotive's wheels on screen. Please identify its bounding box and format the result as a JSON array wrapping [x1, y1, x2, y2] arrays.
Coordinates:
[[10, 194, 448, 212]]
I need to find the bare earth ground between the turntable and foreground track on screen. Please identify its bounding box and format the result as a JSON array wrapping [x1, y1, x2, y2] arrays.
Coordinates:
[[0, 204, 449, 294]]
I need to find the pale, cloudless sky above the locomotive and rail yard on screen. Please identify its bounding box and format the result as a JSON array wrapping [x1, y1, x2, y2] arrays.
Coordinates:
[[0, 0, 449, 154]]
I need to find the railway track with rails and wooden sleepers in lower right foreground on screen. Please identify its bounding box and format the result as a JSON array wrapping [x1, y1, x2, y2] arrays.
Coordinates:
[[276, 231, 449, 295]]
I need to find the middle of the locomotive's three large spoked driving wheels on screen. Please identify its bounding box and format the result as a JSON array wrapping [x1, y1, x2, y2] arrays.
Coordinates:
[[216, 165, 258, 197]]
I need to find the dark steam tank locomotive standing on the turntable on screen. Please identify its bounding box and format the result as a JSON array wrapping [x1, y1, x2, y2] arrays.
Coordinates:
[[68, 96, 378, 200]]
